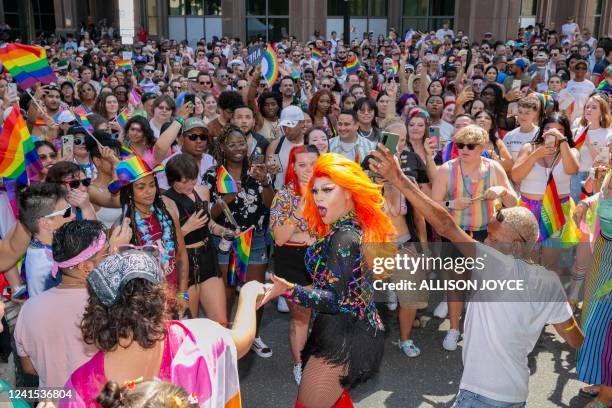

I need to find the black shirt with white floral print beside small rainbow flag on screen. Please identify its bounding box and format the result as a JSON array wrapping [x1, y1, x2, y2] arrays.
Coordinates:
[[202, 166, 266, 231]]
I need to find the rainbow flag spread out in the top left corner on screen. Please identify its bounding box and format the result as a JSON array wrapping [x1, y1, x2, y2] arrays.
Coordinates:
[[0, 43, 57, 90]]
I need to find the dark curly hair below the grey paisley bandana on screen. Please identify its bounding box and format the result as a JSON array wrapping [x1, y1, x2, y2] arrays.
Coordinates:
[[81, 278, 172, 352]]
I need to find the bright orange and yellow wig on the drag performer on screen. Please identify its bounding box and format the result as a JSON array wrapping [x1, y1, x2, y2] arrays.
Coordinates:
[[304, 153, 395, 244]]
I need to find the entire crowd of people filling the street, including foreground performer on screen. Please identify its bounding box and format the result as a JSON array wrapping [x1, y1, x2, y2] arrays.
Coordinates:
[[0, 17, 612, 408]]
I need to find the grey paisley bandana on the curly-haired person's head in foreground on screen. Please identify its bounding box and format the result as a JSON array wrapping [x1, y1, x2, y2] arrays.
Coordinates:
[[87, 249, 162, 306]]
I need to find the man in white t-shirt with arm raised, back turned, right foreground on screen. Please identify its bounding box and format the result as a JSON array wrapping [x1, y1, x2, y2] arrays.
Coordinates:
[[370, 146, 584, 408]]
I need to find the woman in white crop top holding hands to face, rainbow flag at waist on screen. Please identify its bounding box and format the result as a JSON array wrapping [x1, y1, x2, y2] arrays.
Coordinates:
[[511, 112, 578, 270]]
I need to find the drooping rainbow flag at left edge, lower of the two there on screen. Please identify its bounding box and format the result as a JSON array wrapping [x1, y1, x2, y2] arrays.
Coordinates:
[[0, 104, 41, 185]]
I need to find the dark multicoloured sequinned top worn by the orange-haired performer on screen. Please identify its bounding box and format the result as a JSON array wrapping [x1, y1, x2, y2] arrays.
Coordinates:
[[286, 212, 385, 330]]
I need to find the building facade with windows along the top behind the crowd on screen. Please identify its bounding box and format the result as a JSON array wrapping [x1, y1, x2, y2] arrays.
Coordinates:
[[0, 0, 612, 43]]
